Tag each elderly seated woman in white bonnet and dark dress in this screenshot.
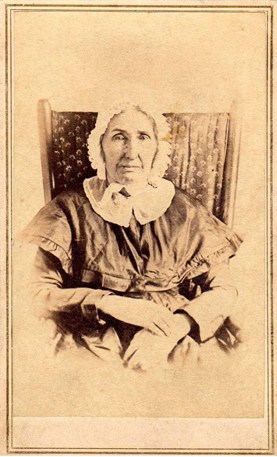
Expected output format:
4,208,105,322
24,105,240,370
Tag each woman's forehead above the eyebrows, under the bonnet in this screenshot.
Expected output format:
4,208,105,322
104,109,156,136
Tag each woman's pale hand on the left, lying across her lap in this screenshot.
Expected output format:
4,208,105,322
97,295,174,336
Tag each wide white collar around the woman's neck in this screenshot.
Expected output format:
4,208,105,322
83,176,175,227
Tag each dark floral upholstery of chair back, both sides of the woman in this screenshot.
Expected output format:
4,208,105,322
51,111,229,217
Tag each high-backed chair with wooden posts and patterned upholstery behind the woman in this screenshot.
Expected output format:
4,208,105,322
38,100,240,227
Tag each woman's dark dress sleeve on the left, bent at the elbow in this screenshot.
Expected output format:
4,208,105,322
31,248,111,323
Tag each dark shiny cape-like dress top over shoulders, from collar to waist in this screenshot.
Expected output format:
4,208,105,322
23,184,240,293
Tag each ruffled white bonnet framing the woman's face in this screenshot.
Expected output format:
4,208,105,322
88,103,171,179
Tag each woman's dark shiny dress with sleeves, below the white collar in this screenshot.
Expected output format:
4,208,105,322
23,183,241,356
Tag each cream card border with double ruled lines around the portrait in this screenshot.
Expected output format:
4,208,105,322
0,0,276,454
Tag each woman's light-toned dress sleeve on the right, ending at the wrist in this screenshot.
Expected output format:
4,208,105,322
177,263,237,342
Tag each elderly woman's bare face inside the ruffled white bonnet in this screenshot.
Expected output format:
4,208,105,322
101,109,158,185
